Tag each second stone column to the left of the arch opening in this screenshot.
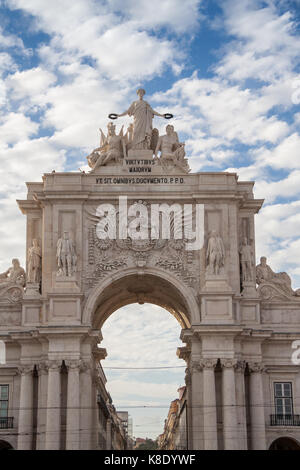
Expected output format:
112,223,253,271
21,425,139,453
65,360,81,450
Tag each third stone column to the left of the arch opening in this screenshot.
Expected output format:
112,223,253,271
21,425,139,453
45,361,61,450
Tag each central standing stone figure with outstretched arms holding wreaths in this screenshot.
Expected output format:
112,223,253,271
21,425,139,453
109,88,173,150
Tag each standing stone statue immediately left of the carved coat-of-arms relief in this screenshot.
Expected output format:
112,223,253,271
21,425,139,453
56,231,77,277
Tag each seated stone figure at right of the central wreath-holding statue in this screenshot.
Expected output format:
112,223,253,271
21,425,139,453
155,124,189,171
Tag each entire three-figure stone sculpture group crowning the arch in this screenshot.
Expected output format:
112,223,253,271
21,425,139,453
87,88,190,173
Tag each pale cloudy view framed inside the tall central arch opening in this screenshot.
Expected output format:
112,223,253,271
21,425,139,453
101,303,186,445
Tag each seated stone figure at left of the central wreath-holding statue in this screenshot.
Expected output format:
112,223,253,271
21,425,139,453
87,122,126,171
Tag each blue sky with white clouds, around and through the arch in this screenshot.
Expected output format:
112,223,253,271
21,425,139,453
0,0,300,435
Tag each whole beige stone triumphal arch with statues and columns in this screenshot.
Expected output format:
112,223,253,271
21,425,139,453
0,90,300,449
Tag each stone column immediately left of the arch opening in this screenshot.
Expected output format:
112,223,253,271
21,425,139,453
80,362,95,450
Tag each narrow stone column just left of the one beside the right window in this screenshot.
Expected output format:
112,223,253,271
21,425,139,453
235,361,248,450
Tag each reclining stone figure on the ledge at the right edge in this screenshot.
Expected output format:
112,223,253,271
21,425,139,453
256,256,300,296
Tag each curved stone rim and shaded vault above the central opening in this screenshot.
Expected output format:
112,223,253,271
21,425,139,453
82,268,200,328
